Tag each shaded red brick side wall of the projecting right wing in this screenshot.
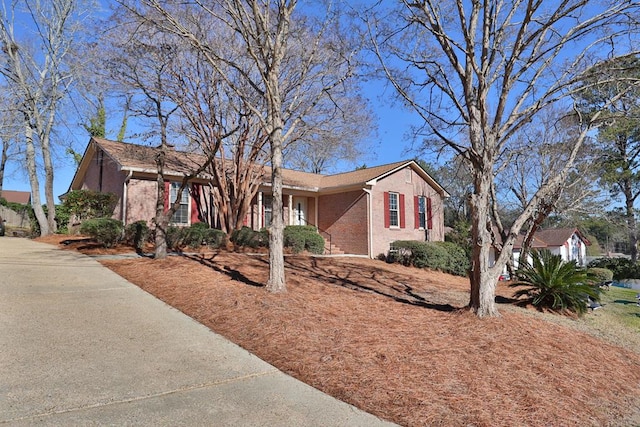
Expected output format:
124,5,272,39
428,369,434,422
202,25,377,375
318,191,368,255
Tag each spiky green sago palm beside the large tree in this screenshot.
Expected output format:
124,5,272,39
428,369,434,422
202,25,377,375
510,250,600,315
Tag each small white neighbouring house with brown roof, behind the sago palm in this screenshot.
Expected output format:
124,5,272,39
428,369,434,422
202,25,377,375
490,228,591,272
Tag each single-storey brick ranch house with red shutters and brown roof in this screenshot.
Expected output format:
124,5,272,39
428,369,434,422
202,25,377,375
69,138,449,258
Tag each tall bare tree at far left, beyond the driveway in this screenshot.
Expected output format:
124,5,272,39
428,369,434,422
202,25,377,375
0,0,84,235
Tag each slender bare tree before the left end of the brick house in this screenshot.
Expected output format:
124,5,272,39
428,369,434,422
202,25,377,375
101,14,215,259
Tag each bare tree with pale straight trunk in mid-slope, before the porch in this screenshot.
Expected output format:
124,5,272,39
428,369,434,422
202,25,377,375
129,0,360,292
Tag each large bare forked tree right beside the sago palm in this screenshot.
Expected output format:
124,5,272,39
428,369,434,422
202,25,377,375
366,0,640,317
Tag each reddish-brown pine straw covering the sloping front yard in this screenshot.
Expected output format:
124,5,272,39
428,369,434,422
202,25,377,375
37,237,640,426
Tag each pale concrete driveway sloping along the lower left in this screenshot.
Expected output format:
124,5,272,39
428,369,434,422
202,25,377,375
0,237,392,426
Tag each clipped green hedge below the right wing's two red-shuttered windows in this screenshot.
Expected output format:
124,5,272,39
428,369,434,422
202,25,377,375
387,240,470,276
